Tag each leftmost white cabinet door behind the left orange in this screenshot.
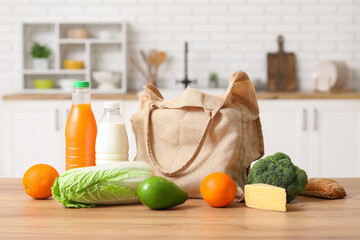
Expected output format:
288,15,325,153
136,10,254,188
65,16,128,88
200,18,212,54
2,101,65,177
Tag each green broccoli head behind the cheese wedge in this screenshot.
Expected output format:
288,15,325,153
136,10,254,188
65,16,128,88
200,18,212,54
248,152,307,202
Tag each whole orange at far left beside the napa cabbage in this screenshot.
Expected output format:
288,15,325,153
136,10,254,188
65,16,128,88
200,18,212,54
23,164,59,198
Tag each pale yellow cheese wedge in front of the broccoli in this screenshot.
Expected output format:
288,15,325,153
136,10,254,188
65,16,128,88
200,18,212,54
245,183,286,212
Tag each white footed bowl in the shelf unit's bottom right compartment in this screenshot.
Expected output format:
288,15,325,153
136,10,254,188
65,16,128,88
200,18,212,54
92,71,121,90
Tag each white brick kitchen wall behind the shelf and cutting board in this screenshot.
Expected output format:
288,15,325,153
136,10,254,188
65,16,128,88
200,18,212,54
0,0,360,175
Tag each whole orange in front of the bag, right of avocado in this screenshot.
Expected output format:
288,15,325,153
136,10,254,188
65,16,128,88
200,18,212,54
200,172,236,207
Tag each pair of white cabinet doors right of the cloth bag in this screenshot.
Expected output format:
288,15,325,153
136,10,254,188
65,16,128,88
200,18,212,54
259,100,360,177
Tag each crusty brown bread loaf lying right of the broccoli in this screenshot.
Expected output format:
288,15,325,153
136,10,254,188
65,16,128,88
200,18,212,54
300,178,346,199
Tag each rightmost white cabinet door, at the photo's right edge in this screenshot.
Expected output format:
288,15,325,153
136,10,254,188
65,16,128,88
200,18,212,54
312,101,360,177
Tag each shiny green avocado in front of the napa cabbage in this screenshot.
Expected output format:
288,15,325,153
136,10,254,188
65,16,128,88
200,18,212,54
137,176,188,210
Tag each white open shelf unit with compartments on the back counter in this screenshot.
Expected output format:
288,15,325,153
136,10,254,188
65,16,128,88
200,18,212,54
22,22,127,93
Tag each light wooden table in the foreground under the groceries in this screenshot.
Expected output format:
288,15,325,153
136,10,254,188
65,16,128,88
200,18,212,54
0,178,360,240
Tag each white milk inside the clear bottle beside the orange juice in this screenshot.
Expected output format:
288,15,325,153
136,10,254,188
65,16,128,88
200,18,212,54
95,122,129,165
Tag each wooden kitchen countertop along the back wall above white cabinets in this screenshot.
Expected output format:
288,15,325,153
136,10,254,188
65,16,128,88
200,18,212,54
2,90,360,100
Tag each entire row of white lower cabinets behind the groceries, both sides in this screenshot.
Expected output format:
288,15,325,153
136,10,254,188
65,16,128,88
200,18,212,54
0,100,360,177
